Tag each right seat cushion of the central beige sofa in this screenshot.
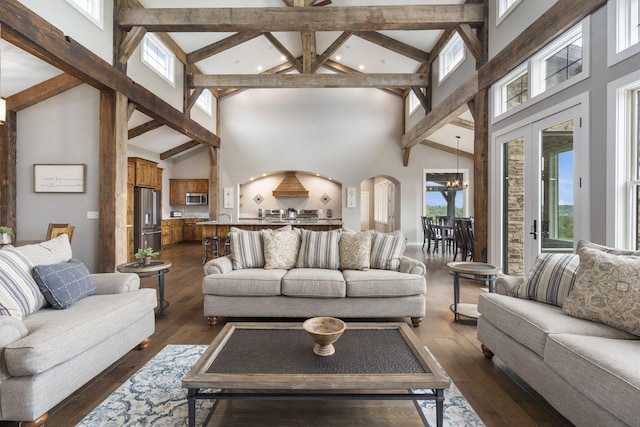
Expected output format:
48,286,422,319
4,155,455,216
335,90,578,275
342,269,427,297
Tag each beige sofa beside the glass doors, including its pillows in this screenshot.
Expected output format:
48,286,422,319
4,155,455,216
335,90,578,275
478,241,640,426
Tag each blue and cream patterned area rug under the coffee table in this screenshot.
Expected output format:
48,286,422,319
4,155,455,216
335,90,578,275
77,345,484,427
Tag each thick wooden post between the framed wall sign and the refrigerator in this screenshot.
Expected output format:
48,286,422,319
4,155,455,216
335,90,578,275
96,90,128,273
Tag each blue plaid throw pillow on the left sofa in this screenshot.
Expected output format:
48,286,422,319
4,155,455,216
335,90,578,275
33,259,97,310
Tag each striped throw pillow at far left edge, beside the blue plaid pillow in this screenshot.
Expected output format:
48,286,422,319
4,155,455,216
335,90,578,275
0,248,45,319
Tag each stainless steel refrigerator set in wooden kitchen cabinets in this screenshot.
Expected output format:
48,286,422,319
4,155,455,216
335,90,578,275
133,187,162,251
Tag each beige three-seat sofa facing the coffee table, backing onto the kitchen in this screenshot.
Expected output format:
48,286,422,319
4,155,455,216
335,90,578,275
202,229,426,326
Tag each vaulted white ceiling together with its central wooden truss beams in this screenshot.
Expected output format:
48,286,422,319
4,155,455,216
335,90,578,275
0,0,485,156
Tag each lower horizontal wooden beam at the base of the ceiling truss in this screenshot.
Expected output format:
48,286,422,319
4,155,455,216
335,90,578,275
188,73,429,88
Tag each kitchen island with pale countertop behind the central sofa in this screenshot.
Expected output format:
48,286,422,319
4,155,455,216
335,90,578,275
196,219,342,254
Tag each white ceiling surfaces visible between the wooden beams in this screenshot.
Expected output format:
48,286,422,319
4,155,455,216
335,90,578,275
0,0,473,157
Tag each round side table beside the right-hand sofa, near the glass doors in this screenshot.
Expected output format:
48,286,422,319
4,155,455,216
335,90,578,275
447,261,500,322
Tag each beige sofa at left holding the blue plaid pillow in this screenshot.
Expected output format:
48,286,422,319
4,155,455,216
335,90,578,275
0,235,156,426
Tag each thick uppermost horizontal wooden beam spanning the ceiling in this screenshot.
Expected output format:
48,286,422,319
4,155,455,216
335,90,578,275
118,4,485,33
